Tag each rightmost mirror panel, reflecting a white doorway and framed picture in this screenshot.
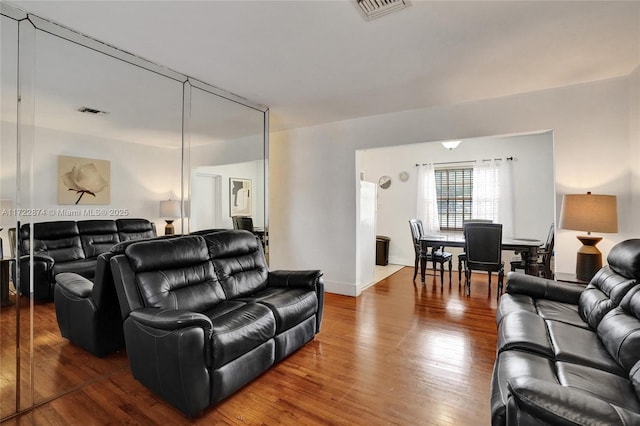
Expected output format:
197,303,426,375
189,83,266,236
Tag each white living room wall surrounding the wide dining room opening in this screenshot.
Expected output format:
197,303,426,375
269,76,640,295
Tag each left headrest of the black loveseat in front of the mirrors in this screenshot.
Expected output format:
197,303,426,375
125,235,209,273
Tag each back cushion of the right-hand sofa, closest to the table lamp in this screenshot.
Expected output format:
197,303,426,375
578,266,636,330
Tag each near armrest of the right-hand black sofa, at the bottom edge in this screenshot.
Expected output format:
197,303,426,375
507,377,640,425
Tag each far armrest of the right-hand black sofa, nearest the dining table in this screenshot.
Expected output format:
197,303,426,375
506,272,585,305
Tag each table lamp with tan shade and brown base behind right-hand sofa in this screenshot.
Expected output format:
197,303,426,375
560,192,618,282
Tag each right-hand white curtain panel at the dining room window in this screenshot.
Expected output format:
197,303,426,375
471,160,514,238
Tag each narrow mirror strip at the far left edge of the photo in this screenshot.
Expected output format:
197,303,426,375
0,10,18,419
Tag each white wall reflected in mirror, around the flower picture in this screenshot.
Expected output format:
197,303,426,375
16,127,181,235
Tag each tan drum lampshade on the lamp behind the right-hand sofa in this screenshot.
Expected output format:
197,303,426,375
560,192,618,233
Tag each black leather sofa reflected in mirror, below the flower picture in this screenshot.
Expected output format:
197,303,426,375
14,218,156,300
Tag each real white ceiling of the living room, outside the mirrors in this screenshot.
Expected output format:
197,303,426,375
9,0,640,131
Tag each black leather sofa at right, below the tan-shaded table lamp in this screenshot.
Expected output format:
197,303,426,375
491,239,640,425
